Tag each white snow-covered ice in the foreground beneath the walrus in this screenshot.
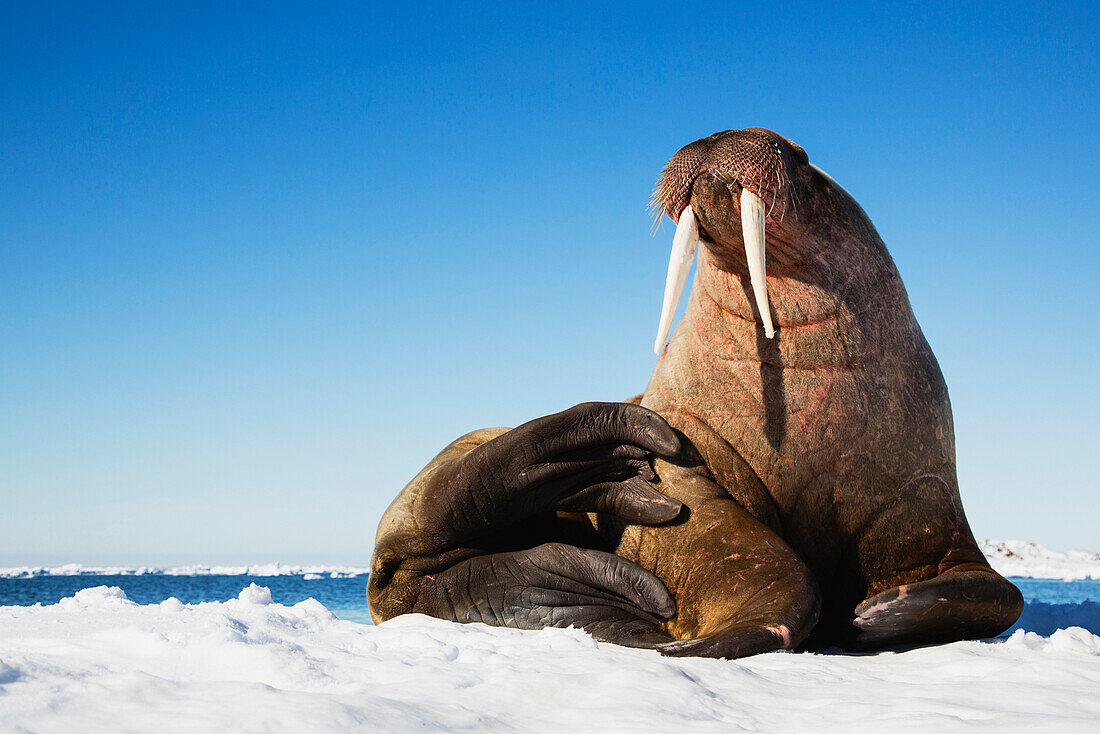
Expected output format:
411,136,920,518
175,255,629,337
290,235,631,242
0,584,1100,732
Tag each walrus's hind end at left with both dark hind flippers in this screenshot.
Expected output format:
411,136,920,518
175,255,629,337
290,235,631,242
367,403,681,644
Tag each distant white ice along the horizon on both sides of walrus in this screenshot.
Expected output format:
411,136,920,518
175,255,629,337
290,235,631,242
0,540,1100,581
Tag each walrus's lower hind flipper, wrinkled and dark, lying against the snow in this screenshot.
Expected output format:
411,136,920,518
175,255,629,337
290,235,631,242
413,543,677,647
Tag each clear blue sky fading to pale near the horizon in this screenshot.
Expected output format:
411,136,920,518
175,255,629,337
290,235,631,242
0,2,1100,566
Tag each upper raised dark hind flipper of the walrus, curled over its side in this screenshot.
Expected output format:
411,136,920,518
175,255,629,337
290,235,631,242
387,403,680,557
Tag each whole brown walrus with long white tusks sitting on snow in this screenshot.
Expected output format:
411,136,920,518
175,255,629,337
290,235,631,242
367,128,1023,658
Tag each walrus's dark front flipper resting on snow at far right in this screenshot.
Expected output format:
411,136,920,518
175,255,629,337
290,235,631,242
847,563,1024,649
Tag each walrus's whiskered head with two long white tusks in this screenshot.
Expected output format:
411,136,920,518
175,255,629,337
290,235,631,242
652,128,833,353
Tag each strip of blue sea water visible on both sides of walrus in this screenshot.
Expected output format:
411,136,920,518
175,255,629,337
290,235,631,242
0,573,1100,635
